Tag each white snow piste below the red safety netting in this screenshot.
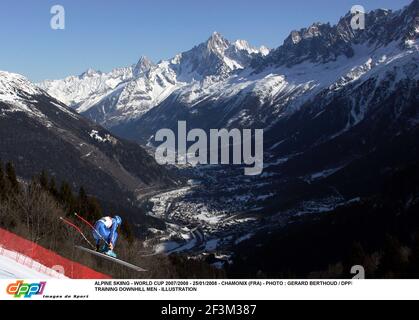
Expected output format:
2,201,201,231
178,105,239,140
0,249,66,279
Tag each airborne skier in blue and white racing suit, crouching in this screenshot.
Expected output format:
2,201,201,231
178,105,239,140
93,216,122,258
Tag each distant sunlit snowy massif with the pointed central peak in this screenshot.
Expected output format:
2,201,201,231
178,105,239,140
38,32,269,127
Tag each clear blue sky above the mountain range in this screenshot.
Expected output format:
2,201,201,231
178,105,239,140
0,0,410,81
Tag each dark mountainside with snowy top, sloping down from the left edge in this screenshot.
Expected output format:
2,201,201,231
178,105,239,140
0,72,176,204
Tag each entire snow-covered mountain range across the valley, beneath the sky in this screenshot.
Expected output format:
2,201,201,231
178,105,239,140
40,1,418,143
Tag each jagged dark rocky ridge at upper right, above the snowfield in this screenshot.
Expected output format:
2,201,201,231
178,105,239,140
252,0,419,71
